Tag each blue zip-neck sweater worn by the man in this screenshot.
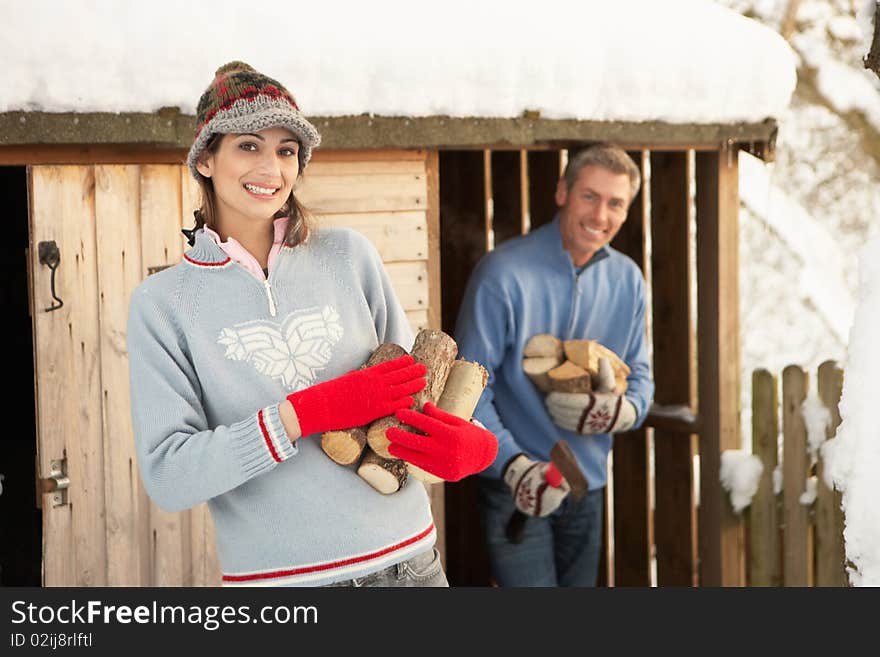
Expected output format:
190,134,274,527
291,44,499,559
455,216,654,489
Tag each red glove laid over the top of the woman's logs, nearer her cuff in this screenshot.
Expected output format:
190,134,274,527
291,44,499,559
287,356,427,436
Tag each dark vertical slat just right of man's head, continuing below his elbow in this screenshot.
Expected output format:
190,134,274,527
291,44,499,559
609,152,654,586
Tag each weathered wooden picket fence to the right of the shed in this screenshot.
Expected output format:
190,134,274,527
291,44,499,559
744,361,848,586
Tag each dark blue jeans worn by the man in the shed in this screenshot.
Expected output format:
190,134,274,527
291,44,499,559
477,477,604,586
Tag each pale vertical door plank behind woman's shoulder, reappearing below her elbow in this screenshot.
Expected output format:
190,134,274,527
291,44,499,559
138,165,189,586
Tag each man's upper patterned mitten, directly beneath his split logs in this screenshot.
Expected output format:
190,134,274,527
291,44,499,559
544,392,637,434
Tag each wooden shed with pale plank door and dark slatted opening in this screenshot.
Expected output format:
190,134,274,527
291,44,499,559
0,110,776,586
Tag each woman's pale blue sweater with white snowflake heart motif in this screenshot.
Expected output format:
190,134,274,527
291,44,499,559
128,229,436,586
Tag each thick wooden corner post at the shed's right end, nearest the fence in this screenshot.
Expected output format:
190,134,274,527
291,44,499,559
696,147,745,586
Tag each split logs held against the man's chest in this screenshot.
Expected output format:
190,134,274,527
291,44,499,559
523,333,630,394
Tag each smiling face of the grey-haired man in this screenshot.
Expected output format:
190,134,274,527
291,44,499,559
556,164,631,267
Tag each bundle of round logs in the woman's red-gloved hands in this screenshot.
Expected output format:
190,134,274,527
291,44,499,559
321,329,488,495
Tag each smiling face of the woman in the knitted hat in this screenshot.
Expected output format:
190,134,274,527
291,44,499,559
196,127,299,233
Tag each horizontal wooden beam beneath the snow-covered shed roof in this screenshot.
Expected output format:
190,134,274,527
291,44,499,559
0,113,776,158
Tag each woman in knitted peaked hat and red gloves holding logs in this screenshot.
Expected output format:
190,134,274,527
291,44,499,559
128,62,497,586
